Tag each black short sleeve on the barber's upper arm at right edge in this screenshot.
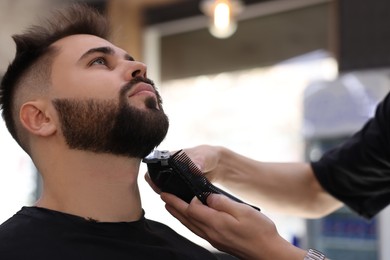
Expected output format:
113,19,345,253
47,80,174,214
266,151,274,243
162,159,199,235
311,94,390,218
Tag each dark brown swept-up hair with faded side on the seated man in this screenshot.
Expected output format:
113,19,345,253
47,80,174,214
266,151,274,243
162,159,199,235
0,4,109,150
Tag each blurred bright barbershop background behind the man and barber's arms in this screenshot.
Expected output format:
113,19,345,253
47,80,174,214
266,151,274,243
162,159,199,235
0,0,390,260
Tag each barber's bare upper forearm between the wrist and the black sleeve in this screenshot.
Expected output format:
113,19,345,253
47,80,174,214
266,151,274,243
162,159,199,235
214,147,342,218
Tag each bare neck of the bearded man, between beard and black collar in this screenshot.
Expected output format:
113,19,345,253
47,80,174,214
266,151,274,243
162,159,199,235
36,151,142,222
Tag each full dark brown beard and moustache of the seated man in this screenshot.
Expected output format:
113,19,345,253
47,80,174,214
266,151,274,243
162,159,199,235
53,78,169,158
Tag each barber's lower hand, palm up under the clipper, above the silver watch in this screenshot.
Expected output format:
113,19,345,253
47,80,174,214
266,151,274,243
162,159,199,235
161,193,305,260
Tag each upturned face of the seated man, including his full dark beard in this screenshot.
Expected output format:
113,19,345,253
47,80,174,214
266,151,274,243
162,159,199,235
50,35,168,158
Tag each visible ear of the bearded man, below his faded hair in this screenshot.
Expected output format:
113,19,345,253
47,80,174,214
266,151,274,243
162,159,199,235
19,101,57,136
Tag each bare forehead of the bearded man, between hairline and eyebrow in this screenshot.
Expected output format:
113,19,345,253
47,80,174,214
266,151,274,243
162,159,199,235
53,34,126,61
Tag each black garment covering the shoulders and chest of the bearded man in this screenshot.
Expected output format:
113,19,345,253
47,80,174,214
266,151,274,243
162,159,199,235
0,207,217,260
